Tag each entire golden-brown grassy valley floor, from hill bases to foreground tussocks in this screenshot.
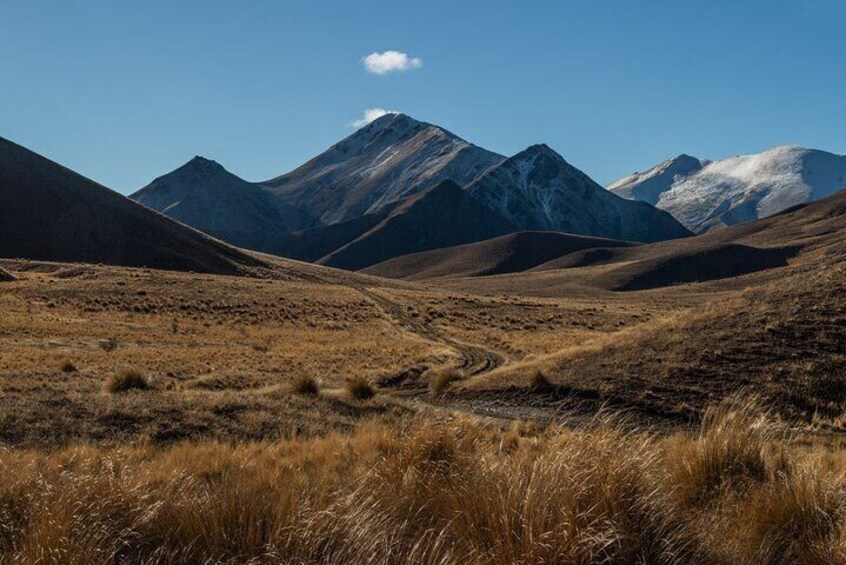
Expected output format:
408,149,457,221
0,261,846,563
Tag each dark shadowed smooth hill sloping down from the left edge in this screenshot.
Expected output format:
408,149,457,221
0,133,265,274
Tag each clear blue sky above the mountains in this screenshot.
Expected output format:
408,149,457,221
0,0,846,193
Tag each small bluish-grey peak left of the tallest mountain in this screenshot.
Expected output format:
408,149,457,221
130,157,314,250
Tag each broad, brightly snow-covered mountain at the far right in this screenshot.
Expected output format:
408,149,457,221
612,146,846,232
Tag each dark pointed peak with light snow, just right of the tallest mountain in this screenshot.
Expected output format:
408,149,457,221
467,145,690,242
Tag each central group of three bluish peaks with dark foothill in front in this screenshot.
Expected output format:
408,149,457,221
132,114,691,269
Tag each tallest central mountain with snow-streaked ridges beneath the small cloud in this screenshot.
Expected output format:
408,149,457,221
261,114,505,224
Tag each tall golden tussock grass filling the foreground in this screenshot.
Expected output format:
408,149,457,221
0,401,846,565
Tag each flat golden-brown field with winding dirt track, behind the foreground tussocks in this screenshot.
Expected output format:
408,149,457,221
0,253,720,447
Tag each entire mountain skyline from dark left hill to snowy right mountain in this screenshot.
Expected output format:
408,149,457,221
0,114,846,280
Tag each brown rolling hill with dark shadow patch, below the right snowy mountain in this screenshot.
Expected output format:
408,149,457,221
428,187,846,296
